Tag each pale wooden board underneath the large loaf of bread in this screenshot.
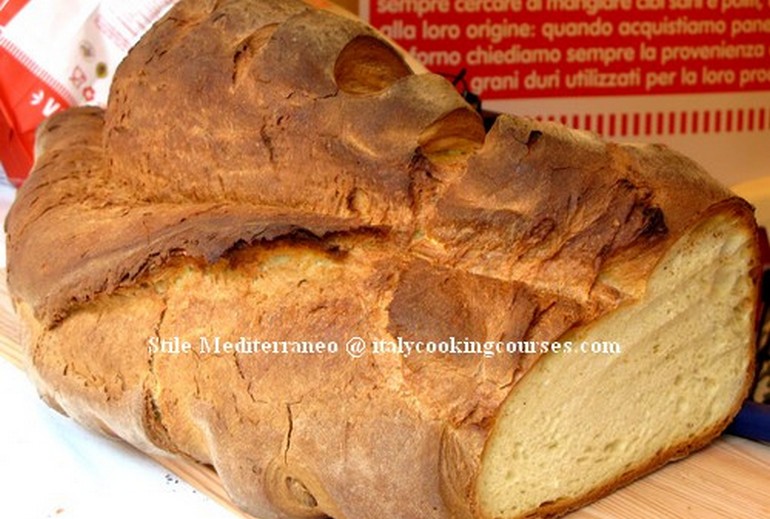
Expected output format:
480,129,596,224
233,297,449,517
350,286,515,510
0,271,770,519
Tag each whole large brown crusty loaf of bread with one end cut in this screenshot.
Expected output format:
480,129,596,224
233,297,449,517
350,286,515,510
6,0,758,519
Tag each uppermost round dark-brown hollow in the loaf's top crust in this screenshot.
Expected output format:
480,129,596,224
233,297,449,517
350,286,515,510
334,36,412,95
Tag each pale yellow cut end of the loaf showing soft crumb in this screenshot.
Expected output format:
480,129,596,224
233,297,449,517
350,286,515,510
476,206,756,518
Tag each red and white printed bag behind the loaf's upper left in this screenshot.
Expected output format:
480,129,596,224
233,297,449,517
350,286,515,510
0,0,176,185
